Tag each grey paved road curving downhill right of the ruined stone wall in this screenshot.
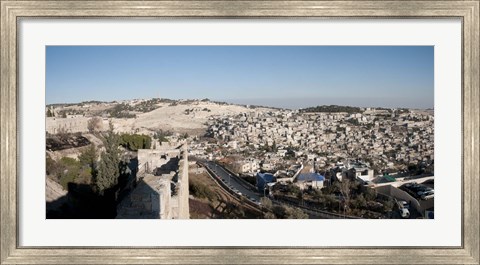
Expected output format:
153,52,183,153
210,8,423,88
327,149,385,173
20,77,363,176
204,161,260,202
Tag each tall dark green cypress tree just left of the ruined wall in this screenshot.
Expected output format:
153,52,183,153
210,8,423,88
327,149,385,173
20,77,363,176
95,121,120,194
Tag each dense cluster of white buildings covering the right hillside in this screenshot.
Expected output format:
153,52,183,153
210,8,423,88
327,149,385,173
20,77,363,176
193,108,434,176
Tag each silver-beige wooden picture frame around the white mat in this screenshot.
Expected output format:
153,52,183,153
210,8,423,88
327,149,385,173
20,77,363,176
0,0,480,264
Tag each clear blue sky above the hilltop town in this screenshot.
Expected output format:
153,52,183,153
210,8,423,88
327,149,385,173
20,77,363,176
46,46,434,109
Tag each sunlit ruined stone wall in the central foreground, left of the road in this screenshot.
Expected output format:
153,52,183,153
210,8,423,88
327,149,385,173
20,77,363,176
117,146,190,219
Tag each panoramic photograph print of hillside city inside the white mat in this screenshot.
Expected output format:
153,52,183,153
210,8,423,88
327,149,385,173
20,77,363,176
45,46,434,219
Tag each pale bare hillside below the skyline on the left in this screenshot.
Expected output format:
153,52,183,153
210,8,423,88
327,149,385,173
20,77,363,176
47,100,274,135
